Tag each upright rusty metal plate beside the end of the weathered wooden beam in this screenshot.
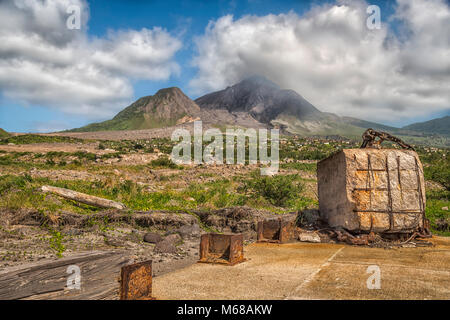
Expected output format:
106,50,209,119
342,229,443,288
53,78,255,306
120,260,154,300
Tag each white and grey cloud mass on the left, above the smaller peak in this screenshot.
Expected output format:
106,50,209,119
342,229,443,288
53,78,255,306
0,0,181,119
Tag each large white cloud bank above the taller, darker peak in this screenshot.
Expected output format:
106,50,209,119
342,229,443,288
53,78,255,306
190,0,450,121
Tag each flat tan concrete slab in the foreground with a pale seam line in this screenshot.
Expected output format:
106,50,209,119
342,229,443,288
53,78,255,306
153,236,450,300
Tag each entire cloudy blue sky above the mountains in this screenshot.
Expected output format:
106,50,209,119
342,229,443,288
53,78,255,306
0,0,450,132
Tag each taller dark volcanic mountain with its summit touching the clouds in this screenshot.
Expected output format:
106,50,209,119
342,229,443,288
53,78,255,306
195,76,396,137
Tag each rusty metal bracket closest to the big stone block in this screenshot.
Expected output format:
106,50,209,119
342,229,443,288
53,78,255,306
257,218,295,243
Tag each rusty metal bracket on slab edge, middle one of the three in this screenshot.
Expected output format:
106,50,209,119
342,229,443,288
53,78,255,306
198,233,245,266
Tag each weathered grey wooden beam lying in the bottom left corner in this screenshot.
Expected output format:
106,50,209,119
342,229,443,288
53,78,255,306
0,251,131,300
